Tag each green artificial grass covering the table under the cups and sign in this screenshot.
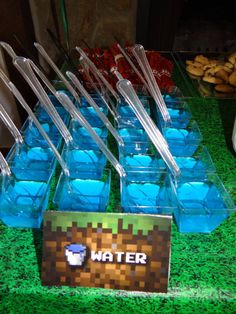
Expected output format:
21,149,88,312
0,76,236,314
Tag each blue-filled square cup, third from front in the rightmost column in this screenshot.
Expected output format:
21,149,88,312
162,121,202,157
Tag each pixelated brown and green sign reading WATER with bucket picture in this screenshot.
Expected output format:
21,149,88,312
42,211,171,292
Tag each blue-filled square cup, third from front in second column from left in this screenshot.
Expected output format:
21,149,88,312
70,120,108,150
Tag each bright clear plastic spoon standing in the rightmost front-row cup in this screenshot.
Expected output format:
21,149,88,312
117,80,180,177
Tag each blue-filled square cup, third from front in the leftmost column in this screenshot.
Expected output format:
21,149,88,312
21,118,62,148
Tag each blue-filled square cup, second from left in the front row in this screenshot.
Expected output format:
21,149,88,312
53,170,111,212
